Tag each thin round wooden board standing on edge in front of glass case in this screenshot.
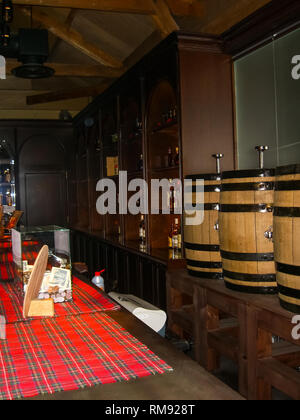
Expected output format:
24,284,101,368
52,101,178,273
23,245,49,318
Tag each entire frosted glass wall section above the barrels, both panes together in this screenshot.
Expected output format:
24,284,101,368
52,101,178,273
235,29,300,169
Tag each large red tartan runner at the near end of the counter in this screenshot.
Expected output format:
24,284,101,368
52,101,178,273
0,313,172,400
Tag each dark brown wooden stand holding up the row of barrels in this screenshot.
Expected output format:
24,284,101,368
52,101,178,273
167,270,300,400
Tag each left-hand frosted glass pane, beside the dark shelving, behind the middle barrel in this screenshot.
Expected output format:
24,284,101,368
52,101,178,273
235,44,277,169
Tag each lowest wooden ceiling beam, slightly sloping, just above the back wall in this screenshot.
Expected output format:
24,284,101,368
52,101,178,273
26,83,110,105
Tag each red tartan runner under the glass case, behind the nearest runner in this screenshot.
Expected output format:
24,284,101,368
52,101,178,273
0,277,120,323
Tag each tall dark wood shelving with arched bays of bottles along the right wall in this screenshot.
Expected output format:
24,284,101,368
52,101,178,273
69,34,234,307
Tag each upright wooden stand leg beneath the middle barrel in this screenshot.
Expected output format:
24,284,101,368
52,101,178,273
247,307,272,400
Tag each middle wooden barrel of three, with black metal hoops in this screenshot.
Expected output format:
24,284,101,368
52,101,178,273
219,170,277,294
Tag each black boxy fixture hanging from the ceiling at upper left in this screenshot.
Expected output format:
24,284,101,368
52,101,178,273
0,29,55,79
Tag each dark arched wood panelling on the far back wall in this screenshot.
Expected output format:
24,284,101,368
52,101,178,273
0,121,73,226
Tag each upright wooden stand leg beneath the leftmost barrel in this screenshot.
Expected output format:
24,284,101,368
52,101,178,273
196,288,220,372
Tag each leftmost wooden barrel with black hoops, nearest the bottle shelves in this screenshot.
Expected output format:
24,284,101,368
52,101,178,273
184,174,222,279
